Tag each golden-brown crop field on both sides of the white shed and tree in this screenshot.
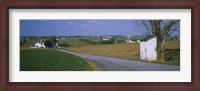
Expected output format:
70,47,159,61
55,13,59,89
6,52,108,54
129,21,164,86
65,40,180,65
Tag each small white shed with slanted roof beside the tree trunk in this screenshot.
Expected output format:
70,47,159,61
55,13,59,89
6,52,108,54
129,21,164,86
140,36,157,61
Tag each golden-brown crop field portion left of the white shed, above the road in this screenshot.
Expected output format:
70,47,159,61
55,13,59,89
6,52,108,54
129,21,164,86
66,43,139,59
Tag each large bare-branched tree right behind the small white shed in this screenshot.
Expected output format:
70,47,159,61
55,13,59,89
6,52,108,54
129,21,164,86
139,20,180,61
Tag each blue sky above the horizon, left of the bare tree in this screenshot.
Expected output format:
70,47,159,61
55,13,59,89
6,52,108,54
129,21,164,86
20,20,180,36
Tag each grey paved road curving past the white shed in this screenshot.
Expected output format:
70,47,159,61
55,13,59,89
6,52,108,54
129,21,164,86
57,49,180,71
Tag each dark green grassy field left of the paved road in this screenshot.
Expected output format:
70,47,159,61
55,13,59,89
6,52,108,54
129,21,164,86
20,49,90,71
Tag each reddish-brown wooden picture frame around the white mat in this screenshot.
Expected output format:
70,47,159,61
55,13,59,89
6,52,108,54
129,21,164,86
0,0,200,91
